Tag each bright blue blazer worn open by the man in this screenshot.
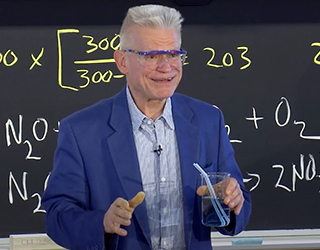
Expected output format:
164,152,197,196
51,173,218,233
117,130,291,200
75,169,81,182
42,88,251,250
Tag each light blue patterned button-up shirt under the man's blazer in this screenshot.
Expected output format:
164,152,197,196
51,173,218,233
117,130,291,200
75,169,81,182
127,87,185,250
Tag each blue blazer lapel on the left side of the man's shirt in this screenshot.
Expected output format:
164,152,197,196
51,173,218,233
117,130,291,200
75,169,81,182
108,88,151,246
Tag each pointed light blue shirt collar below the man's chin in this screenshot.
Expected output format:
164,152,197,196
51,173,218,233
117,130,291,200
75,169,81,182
126,85,175,132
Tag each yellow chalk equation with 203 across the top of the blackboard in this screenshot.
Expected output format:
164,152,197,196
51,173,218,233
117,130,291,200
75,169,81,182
0,28,320,94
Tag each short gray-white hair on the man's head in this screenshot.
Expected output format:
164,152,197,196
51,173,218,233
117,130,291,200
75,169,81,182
120,4,183,49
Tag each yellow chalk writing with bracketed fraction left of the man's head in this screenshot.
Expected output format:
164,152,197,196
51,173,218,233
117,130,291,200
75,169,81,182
0,29,124,91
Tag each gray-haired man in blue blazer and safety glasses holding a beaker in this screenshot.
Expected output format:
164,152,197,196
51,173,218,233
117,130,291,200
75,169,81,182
42,5,251,250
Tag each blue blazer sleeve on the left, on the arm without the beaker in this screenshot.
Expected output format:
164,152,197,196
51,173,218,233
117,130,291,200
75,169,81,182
42,120,105,249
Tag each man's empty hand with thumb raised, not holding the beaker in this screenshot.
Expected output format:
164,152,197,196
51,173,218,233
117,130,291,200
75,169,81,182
103,191,145,236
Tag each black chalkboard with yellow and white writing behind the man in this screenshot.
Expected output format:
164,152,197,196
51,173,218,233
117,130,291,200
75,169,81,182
0,0,320,237
